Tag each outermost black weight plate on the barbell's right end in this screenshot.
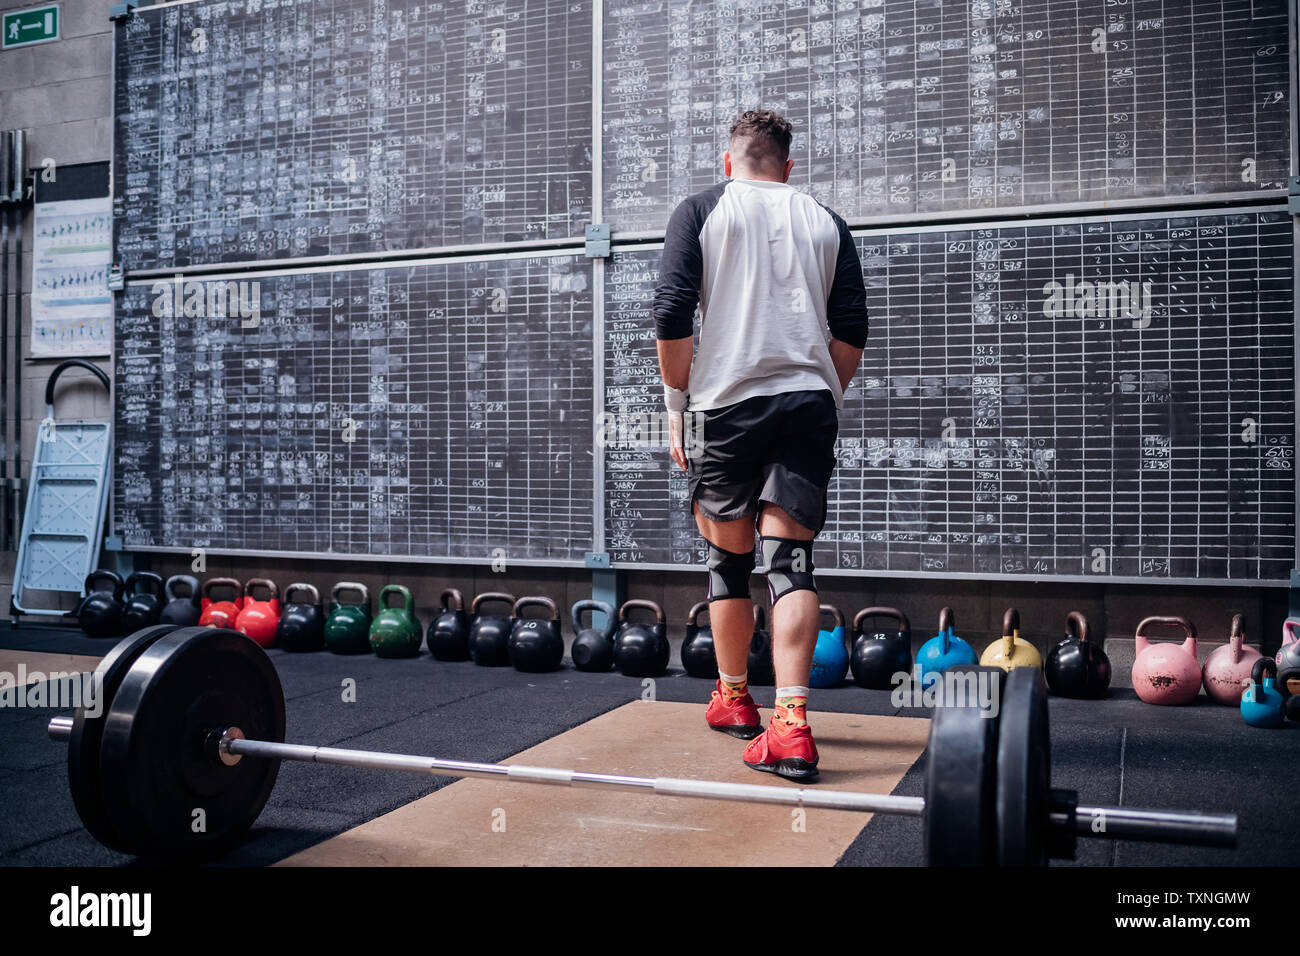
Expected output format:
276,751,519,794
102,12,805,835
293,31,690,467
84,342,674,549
997,667,1052,866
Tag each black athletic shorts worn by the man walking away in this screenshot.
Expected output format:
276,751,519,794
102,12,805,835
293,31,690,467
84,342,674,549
686,390,840,532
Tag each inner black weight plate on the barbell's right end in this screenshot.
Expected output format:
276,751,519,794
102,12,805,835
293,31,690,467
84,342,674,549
923,706,998,866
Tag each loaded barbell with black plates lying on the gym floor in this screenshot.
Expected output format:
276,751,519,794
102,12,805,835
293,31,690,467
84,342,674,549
48,624,1238,866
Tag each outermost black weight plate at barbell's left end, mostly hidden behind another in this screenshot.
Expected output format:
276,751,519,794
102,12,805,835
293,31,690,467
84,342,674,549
68,624,177,849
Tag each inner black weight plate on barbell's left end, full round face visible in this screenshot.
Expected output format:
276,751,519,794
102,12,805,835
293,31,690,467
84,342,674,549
100,628,285,858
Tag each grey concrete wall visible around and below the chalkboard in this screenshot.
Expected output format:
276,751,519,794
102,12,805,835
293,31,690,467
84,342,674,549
0,0,1286,660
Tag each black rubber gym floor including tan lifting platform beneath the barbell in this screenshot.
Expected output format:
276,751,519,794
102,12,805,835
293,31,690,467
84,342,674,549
0,628,1300,866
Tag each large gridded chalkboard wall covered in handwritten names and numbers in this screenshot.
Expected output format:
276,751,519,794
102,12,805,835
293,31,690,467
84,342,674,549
113,0,1296,583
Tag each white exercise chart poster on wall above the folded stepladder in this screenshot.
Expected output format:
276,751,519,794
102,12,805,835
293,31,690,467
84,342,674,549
31,195,113,358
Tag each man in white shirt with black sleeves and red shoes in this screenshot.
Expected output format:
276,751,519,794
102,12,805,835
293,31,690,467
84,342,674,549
654,109,867,782
